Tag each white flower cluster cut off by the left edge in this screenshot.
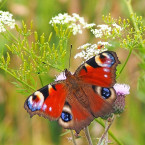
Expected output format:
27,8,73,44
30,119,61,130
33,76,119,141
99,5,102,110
0,11,15,32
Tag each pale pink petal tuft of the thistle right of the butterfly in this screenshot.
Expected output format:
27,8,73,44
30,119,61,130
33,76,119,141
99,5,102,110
113,84,130,95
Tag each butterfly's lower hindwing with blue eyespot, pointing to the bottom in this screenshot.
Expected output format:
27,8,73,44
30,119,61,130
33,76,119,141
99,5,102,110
58,91,94,133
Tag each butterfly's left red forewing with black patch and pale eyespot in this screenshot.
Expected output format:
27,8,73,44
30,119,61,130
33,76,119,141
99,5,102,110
24,81,67,120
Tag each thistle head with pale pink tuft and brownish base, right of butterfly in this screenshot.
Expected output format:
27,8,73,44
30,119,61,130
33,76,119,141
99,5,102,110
113,84,130,114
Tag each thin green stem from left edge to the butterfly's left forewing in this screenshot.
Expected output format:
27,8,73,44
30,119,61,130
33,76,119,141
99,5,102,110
0,67,36,91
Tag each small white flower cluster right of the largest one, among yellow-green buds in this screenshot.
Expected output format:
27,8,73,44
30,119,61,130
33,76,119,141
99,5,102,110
91,23,123,38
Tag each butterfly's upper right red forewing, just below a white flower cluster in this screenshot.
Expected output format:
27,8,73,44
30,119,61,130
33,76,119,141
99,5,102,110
74,51,119,87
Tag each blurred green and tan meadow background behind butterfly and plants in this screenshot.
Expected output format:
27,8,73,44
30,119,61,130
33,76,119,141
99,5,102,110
0,0,145,145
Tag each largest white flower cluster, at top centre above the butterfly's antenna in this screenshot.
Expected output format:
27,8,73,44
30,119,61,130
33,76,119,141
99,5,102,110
49,13,96,35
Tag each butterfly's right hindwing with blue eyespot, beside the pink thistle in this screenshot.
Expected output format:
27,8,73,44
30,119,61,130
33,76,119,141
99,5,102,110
82,85,116,118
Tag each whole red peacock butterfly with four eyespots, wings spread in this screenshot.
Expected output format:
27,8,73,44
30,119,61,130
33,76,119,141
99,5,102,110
24,51,120,133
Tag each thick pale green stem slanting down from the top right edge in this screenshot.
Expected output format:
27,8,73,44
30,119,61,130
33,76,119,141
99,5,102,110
124,0,144,47
